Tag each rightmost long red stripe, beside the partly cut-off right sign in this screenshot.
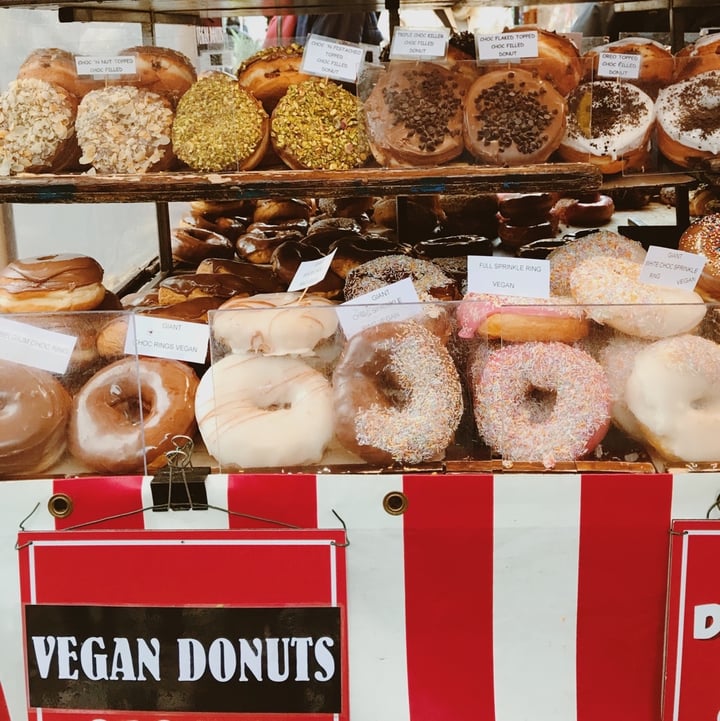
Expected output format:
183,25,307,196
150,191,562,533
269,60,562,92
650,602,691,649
577,474,672,721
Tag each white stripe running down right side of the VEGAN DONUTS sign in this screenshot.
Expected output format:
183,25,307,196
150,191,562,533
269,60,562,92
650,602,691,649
317,475,410,721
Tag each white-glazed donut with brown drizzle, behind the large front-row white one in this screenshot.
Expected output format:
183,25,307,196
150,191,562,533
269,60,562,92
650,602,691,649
213,293,338,356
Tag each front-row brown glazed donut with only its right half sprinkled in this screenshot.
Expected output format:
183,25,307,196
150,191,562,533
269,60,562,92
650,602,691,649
332,322,463,465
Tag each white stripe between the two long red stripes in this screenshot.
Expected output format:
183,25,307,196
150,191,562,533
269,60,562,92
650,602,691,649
493,474,581,721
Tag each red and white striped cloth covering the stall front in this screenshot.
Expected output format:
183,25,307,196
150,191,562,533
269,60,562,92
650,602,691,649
0,474,720,721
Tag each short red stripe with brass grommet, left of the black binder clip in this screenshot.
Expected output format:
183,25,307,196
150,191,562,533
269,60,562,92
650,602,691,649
53,476,145,531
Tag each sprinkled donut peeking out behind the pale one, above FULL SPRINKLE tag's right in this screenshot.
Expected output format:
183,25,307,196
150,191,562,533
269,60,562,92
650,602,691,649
547,230,645,295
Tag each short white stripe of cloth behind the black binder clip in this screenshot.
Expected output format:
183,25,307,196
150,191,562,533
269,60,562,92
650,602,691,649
141,474,230,530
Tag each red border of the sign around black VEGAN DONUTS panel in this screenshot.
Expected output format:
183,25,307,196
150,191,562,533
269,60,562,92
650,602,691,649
18,529,350,721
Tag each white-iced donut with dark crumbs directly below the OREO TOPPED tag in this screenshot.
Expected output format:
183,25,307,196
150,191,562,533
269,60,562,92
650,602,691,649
558,80,655,175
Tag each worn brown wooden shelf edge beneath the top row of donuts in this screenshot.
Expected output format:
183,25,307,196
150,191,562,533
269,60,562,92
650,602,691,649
0,163,602,204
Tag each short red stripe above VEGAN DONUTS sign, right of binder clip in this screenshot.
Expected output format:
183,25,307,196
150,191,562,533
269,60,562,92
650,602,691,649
228,474,317,528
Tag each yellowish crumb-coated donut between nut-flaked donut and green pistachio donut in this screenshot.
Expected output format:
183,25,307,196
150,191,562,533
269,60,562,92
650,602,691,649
172,72,270,172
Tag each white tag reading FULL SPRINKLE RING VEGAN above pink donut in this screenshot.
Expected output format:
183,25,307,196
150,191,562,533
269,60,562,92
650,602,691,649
468,255,550,298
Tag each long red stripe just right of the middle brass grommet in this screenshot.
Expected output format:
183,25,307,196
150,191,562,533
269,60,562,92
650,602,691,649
404,475,495,721
